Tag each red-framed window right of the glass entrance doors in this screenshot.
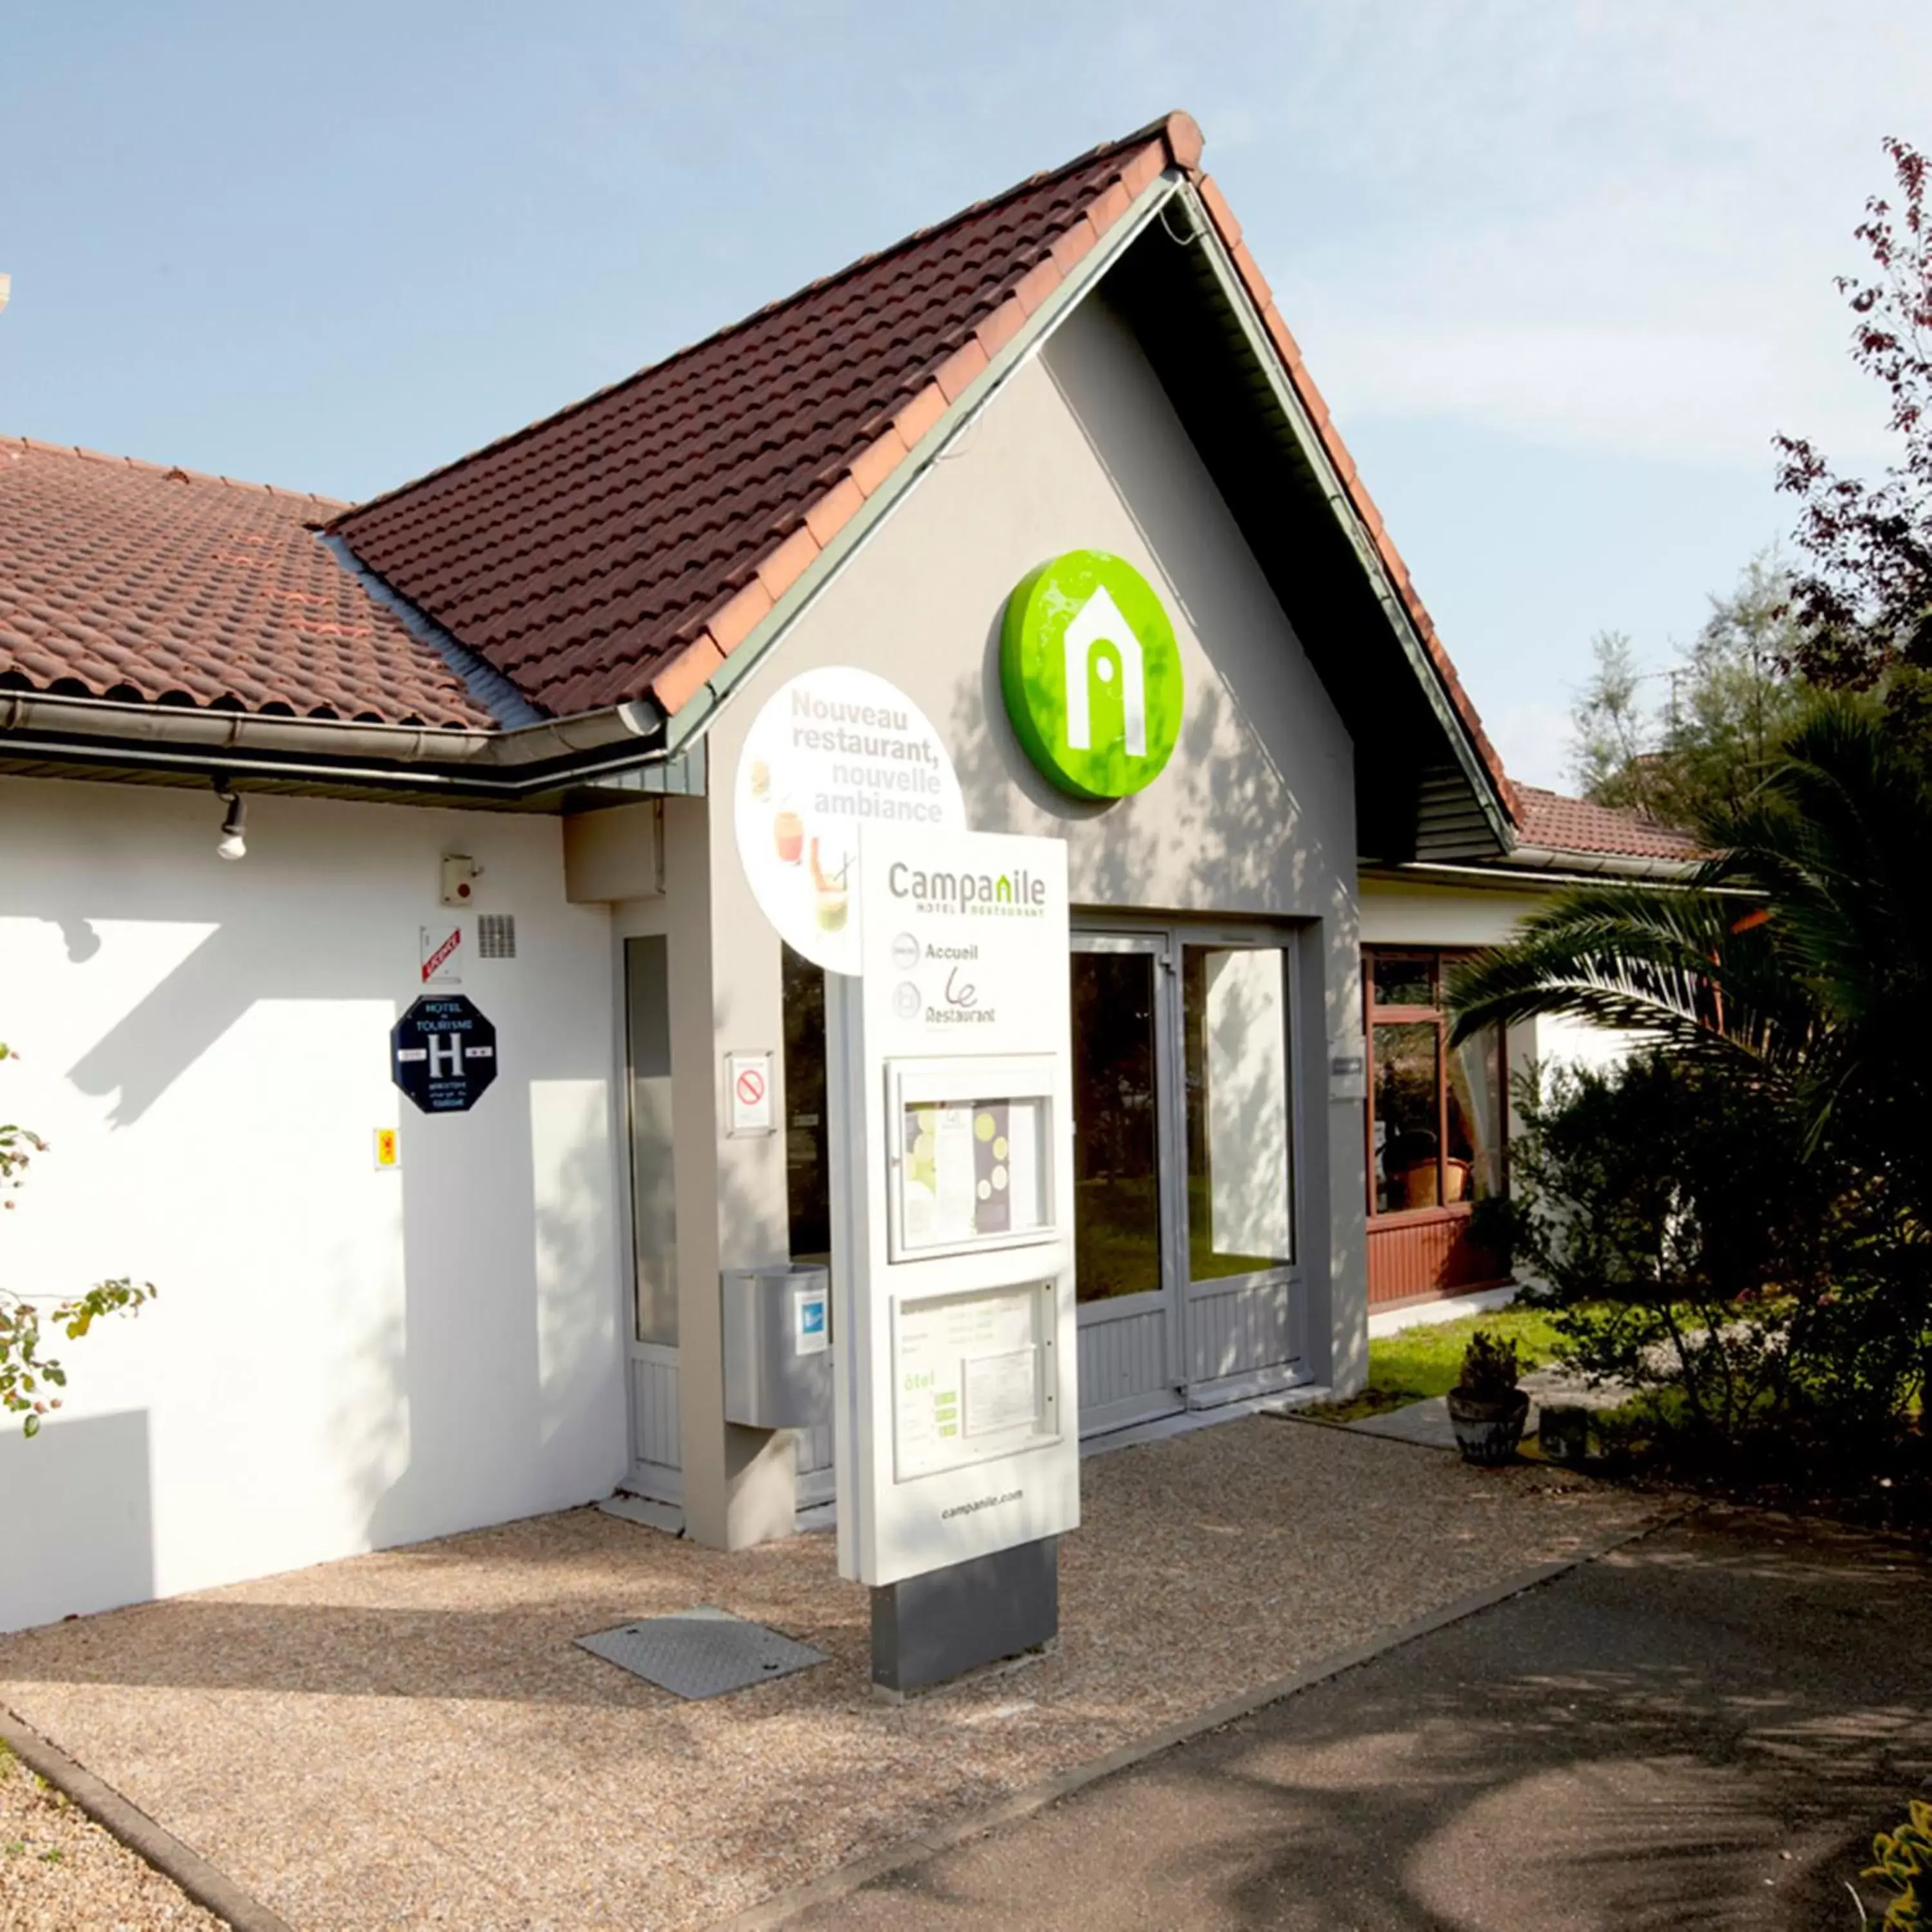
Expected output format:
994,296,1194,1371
1364,949,1509,1215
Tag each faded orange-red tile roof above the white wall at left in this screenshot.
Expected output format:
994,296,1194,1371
0,437,491,726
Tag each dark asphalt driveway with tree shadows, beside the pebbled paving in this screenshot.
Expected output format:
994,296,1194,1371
773,1515,1932,1932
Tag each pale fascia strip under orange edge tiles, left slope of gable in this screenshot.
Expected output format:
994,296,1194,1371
665,168,1186,748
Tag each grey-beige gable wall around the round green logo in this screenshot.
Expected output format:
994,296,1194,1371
665,298,1366,1548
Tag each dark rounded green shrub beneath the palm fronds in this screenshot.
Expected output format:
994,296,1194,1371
1511,1053,1932,1461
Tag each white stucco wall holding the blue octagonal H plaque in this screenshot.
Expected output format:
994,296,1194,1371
0,779,626,1629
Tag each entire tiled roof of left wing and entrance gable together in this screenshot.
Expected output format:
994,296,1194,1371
0,114,1520,817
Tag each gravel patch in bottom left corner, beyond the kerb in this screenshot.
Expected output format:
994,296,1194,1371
0,1745,222,1932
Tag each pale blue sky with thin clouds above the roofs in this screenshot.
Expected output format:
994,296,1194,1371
0,0,1932,784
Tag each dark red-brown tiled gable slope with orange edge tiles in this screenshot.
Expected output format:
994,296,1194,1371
334,116,1200,713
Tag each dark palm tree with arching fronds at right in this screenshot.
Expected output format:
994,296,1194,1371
1449,699,1932,1437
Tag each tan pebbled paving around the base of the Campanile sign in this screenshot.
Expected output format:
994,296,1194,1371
0,1418,1660,1932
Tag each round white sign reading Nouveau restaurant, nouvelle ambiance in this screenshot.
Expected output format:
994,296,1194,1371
734,665,966,974
